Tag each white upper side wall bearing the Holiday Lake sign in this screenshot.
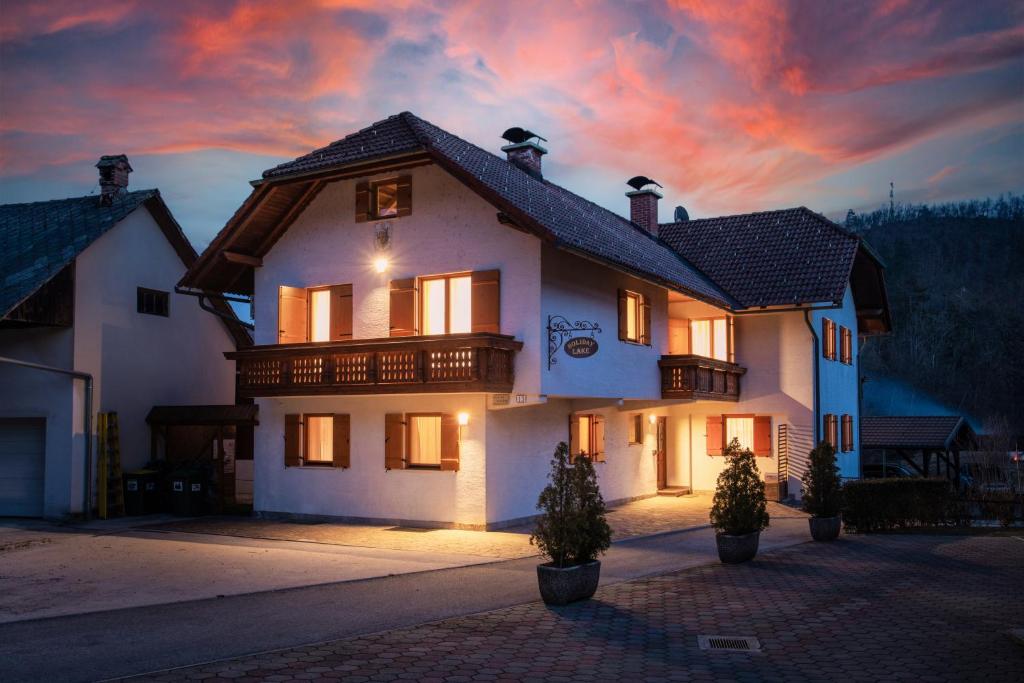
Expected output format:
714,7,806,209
539,247,668,399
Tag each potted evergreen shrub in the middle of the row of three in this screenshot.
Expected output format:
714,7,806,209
711,438,768,564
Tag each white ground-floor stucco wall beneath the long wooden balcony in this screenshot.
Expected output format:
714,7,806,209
254,394,487,526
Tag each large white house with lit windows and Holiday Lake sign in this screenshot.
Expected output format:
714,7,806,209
181,113,889,528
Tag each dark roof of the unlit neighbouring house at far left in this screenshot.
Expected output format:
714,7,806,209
0,189,252,347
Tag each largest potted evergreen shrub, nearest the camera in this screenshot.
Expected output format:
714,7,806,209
529,441,611,605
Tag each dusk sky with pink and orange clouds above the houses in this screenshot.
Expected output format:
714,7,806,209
0,0,1024,249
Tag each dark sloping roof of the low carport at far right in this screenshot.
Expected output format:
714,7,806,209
860,415,976,451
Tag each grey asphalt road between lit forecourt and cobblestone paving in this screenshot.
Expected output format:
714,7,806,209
0,518,809,682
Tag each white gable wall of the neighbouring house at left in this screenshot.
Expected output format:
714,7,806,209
75,208,234,479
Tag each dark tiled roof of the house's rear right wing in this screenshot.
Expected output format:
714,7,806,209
658,207,860,307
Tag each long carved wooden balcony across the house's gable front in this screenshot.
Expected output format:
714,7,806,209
224,334,522,397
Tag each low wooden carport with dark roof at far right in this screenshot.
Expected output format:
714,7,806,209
860,415,978,485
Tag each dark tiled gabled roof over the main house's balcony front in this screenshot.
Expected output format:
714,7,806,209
190,112,735,307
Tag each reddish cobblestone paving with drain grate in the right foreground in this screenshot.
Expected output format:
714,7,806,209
132,536,1024,683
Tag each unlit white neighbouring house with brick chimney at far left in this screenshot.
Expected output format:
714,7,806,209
0,156,246,517
